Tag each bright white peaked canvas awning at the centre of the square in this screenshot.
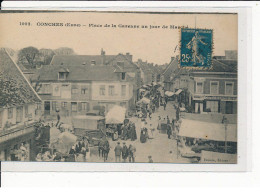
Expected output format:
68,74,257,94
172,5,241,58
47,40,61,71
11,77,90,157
106,105,126,124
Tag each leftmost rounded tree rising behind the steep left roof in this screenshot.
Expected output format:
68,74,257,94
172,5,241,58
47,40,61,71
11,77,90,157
18,47,40,68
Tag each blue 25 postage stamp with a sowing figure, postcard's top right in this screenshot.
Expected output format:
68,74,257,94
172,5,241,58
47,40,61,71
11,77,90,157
180,28,213,67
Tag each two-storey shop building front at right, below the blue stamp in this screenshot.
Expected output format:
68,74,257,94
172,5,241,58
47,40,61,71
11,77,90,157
188,61,237,114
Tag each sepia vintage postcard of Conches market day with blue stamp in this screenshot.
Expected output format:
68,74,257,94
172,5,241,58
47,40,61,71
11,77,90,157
0,11,239,165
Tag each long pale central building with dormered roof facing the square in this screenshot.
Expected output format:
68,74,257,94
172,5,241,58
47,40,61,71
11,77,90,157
33,59,134,116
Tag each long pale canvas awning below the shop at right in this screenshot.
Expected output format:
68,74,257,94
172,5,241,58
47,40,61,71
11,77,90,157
179,119,237,142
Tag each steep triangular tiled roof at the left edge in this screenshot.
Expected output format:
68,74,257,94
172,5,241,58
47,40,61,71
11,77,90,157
0,49,41,107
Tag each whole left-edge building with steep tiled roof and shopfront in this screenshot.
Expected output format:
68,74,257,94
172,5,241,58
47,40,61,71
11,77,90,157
0,49,41,161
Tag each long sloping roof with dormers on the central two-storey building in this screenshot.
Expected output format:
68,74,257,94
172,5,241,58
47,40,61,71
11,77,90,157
32,65,128,82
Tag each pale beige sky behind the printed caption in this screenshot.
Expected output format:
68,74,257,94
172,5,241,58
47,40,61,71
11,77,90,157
0,12,238,65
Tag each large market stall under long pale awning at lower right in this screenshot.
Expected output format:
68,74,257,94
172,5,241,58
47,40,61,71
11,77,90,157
178,119,237,158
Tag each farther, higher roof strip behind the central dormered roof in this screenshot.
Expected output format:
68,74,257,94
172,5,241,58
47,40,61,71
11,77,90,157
50,55,116,65
